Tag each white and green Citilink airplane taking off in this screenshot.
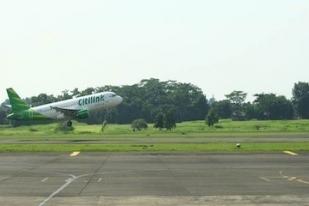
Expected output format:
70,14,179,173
6,88,123,127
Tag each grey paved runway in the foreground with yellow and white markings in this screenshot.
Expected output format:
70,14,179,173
0,153,309,206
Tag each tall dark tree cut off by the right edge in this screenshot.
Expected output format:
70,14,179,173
293,82,309,119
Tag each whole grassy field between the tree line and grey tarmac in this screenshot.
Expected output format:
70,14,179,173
0,120,309,152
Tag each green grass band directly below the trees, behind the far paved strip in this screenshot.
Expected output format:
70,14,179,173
0,120,309,137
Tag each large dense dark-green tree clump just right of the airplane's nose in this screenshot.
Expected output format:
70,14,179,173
113,79,208,123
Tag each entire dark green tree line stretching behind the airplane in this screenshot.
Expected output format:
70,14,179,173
0,78,309,124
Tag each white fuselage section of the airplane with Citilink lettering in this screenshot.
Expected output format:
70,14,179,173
31,92,122,119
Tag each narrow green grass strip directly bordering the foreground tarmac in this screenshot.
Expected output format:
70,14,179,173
0,142,309,152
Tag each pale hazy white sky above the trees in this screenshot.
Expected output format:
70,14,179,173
0,0,309,102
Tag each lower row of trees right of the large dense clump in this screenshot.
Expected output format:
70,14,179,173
209,82,309,120
